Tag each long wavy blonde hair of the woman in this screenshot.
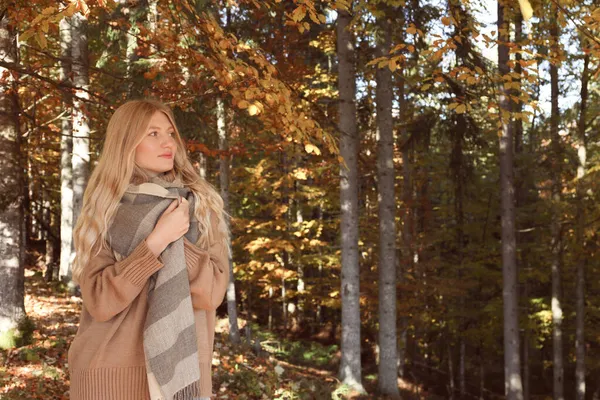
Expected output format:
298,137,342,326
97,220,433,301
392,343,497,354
73,99,229,283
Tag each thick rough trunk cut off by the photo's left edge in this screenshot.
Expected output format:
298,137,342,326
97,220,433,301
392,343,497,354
0,10,25,348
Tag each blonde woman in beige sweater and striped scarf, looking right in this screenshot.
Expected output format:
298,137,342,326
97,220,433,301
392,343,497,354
68,100,229,400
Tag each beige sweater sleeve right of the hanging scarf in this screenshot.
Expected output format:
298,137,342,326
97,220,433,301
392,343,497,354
184,212,229,310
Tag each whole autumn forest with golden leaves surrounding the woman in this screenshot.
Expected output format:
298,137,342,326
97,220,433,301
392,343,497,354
0,0,600,400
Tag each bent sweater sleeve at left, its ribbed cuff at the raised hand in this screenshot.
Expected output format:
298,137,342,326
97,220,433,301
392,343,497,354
81,240,163,322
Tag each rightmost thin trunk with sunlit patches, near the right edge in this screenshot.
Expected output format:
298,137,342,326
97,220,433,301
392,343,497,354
575,53,590,400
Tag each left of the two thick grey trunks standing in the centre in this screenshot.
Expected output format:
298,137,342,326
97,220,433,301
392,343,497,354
337,2,364,392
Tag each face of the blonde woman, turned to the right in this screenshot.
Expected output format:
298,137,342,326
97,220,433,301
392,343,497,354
135,111,177,176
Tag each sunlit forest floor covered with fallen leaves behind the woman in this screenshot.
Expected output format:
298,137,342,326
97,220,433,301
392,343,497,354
0,269,433,400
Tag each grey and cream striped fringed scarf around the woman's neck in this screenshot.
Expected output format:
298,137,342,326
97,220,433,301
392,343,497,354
108,177,200,400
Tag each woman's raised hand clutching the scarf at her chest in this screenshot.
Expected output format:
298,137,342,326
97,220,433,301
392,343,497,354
146,198,190,257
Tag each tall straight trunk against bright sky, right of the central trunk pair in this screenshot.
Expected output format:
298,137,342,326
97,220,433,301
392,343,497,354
498,0,523,400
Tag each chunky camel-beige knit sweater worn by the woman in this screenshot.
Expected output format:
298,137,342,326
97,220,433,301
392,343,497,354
68,221,229,400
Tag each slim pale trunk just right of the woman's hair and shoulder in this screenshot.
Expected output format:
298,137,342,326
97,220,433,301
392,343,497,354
217,98,241,343
